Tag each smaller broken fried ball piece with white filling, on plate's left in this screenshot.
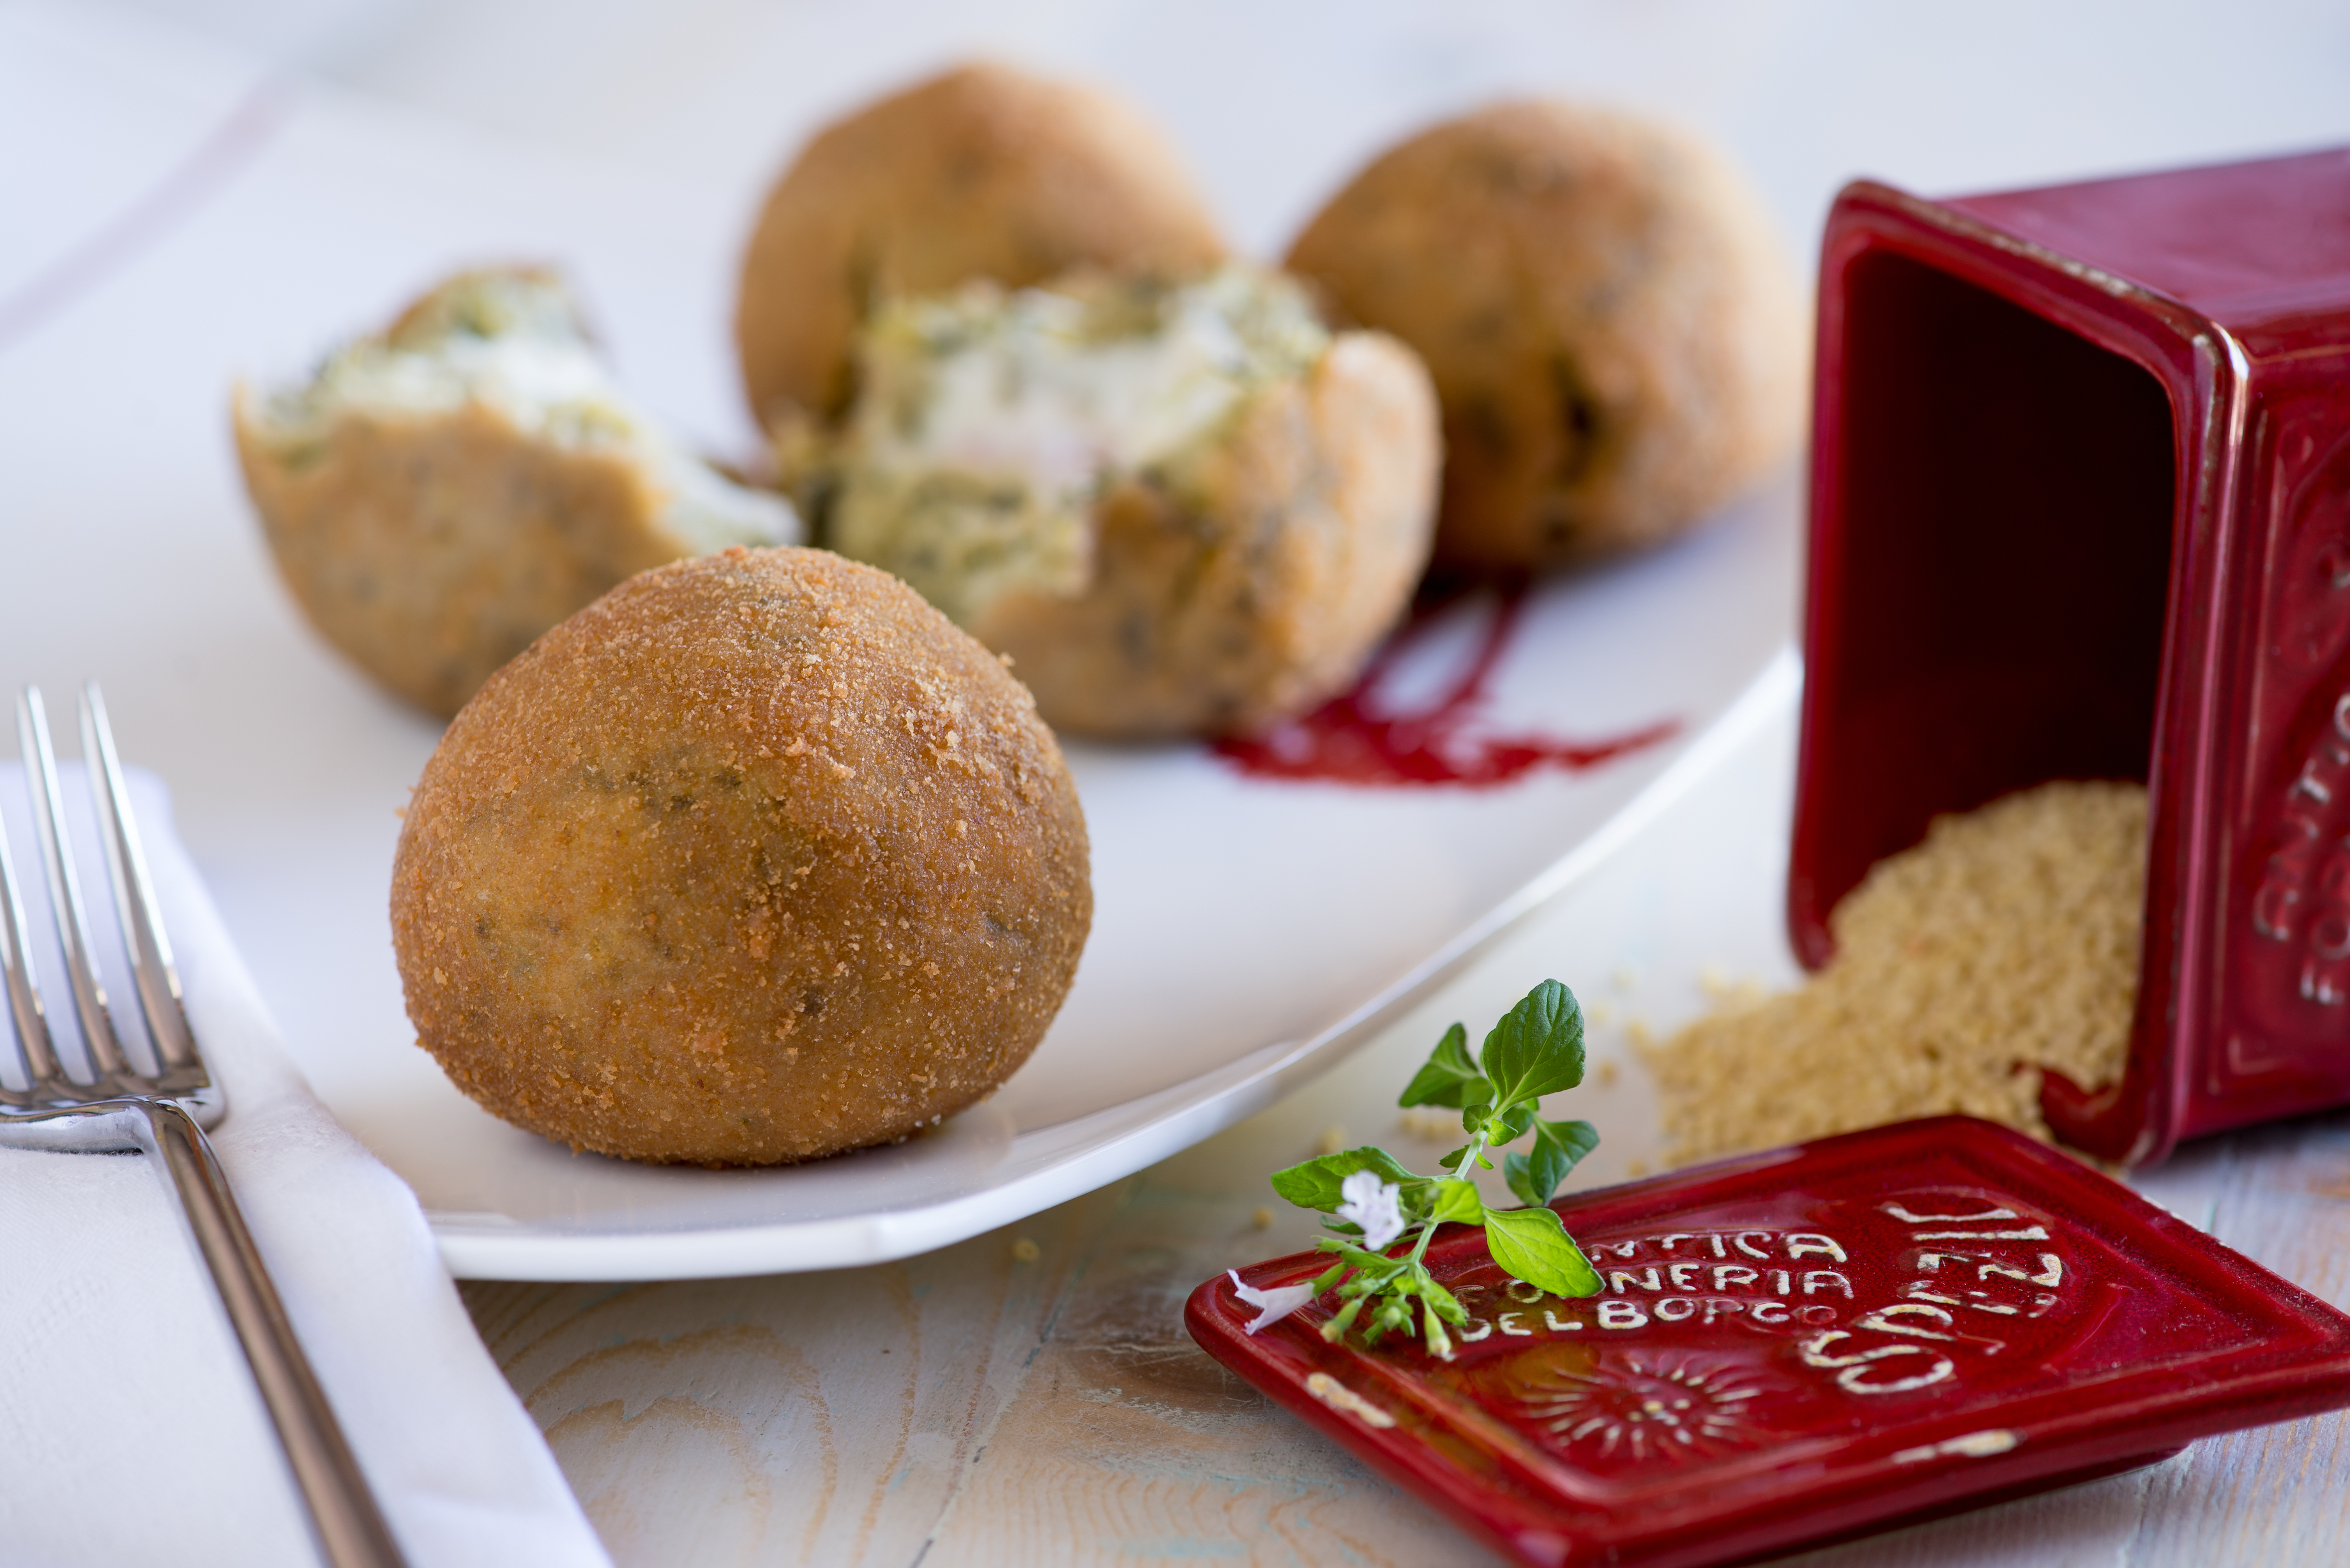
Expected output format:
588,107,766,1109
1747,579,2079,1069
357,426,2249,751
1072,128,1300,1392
232,268,799,717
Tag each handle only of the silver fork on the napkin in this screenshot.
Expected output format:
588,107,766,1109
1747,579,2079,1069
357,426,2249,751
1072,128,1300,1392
139,1100,409,1568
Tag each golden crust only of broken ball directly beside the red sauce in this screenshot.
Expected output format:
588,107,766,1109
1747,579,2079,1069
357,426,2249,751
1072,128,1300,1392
975,331,1438,738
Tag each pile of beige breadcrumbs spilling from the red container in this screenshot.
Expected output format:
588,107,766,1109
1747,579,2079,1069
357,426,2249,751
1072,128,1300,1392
1641,783,2146,1161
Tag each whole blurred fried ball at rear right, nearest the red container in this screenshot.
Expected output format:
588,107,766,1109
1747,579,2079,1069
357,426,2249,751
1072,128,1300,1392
1288,103,1807,569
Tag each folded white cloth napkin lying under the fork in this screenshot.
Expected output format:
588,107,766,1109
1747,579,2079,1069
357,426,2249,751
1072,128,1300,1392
0,764,609,1568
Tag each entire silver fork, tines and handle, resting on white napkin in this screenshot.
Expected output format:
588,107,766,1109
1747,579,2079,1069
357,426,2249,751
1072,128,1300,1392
0,682,407,1568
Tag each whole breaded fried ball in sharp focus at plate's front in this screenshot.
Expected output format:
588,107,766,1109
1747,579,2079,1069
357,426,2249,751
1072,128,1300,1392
393,548,1093,1164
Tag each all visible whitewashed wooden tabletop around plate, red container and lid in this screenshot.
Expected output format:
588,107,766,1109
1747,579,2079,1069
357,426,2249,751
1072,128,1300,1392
463,727,2350,1568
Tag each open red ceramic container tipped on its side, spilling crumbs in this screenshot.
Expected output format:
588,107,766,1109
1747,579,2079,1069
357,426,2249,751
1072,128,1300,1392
1788,151,2350,1161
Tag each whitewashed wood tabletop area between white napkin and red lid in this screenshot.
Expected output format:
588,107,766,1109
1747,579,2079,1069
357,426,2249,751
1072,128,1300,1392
463,1104,1522,1568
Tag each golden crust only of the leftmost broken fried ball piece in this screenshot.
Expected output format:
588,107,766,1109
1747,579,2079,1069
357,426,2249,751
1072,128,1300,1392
235,388,691,717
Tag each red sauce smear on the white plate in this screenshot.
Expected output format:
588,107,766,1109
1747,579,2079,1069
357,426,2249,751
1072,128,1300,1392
1215,580,1680,790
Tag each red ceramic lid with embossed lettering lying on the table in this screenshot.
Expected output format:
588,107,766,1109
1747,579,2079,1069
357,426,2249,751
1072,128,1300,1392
1185,1117,2350,1565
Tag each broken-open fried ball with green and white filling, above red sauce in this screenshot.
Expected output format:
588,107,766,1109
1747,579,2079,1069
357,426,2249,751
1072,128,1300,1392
825,263,1438,738
